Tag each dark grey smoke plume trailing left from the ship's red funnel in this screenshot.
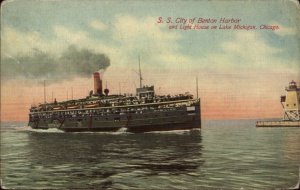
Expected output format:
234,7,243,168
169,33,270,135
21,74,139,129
1,46,110,83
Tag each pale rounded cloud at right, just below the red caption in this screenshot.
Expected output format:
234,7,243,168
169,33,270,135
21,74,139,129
210,31,284,71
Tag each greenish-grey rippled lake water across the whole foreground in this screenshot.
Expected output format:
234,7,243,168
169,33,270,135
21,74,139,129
1,120,300,189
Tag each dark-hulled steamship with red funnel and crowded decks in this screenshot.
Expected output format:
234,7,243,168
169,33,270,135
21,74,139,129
28,64,201,133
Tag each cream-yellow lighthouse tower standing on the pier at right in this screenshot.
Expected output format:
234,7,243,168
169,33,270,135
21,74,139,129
281,81,300,121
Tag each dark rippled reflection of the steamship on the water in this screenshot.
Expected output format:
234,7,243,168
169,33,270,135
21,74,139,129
24,130,204,188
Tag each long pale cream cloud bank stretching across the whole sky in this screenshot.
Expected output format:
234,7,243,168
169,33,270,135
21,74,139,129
1,15,298,88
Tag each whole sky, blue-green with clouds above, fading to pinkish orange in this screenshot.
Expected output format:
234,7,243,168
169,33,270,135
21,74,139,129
1,0,300,121
